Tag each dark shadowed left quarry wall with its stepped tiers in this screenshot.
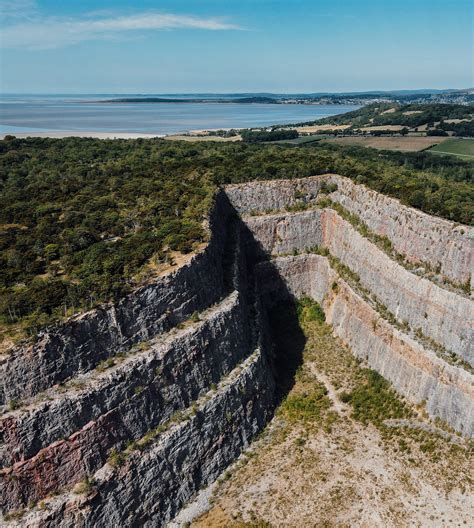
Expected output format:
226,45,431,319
0,194,274,526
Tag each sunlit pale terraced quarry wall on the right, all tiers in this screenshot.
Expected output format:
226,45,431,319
227,175,474,436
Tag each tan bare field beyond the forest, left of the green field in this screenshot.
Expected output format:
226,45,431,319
324,136,446,152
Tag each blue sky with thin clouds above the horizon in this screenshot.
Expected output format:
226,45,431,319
0,0,474,93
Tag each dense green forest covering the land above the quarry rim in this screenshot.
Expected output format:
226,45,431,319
0,137,474,340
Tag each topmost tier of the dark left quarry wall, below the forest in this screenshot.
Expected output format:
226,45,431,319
0,194,235,404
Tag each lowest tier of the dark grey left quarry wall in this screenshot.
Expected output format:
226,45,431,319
19,349,273,528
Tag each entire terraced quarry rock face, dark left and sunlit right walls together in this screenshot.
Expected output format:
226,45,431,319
0,175,474,527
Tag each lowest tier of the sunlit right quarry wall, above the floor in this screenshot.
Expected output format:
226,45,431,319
258,255,474,436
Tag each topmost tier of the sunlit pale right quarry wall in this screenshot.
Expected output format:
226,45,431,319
226,174,474,284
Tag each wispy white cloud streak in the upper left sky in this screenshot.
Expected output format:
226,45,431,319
1,11,242,49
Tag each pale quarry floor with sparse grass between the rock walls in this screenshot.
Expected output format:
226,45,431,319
191,306,474,528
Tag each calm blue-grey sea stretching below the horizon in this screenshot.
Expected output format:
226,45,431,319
0,94,359,135
